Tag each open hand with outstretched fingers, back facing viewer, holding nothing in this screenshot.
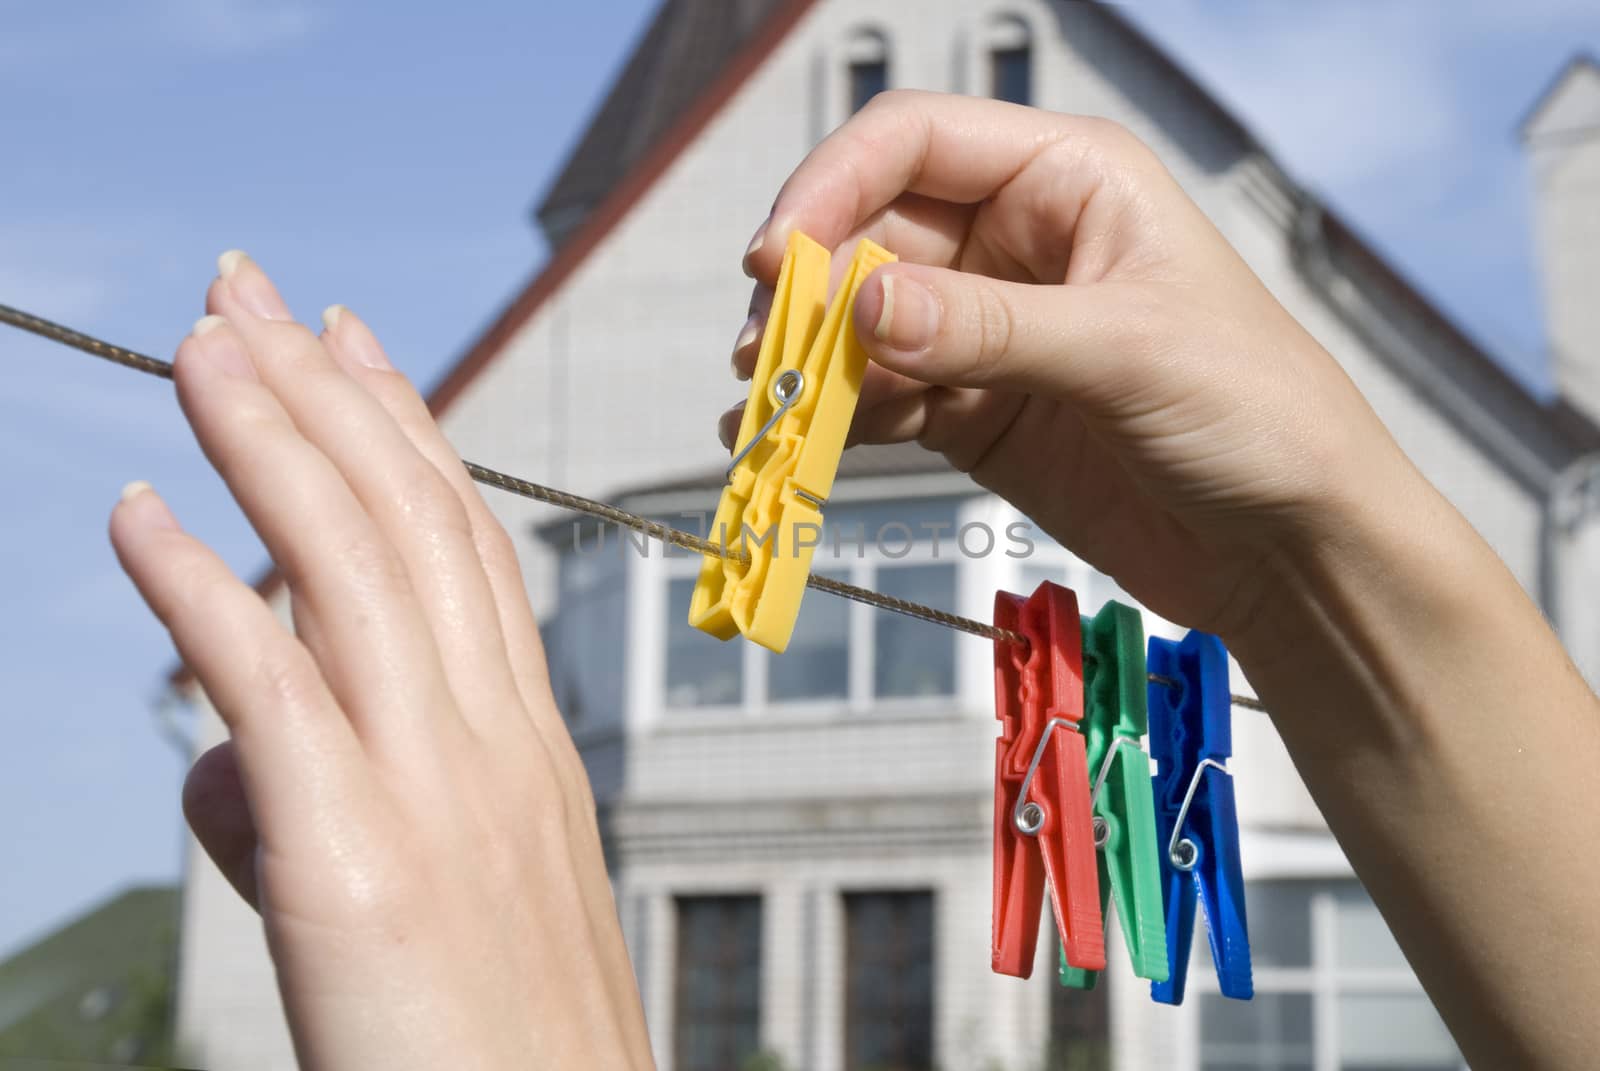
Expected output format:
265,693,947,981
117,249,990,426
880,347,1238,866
110,253,650,1071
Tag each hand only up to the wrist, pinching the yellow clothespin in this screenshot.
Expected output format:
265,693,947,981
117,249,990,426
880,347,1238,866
723,93,1414,656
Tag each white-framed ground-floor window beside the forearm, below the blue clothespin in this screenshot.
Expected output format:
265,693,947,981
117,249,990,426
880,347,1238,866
1189,880,1466,1071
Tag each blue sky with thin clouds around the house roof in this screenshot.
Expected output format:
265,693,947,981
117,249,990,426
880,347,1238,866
0,0,1600,954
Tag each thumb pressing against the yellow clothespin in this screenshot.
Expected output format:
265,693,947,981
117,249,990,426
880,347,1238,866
856,264,1154,400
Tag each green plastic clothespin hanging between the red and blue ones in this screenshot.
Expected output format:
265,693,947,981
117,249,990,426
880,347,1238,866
1061,602,1166,989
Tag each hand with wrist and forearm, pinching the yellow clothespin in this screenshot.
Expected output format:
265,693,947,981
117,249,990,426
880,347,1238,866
723,93,1600,1068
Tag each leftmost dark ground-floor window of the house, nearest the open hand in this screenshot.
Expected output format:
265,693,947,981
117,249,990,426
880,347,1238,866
672,897,762,1071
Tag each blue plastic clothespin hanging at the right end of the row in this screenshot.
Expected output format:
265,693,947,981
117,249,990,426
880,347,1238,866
1149,632,1254,1004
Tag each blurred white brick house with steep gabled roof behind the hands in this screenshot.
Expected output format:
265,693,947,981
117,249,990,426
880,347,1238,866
168,0,1600,1071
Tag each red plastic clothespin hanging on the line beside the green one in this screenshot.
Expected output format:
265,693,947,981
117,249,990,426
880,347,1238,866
992,581,1106,978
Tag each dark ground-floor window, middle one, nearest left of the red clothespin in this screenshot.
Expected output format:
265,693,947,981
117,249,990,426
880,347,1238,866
845,892,933,1071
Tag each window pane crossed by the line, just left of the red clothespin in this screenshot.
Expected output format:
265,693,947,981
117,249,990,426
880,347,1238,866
872,564,955,696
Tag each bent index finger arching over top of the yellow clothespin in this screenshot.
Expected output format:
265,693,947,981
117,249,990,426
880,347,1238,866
746,90,1098,285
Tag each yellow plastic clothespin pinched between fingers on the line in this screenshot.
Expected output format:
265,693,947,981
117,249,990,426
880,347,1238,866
690,234,894,653
